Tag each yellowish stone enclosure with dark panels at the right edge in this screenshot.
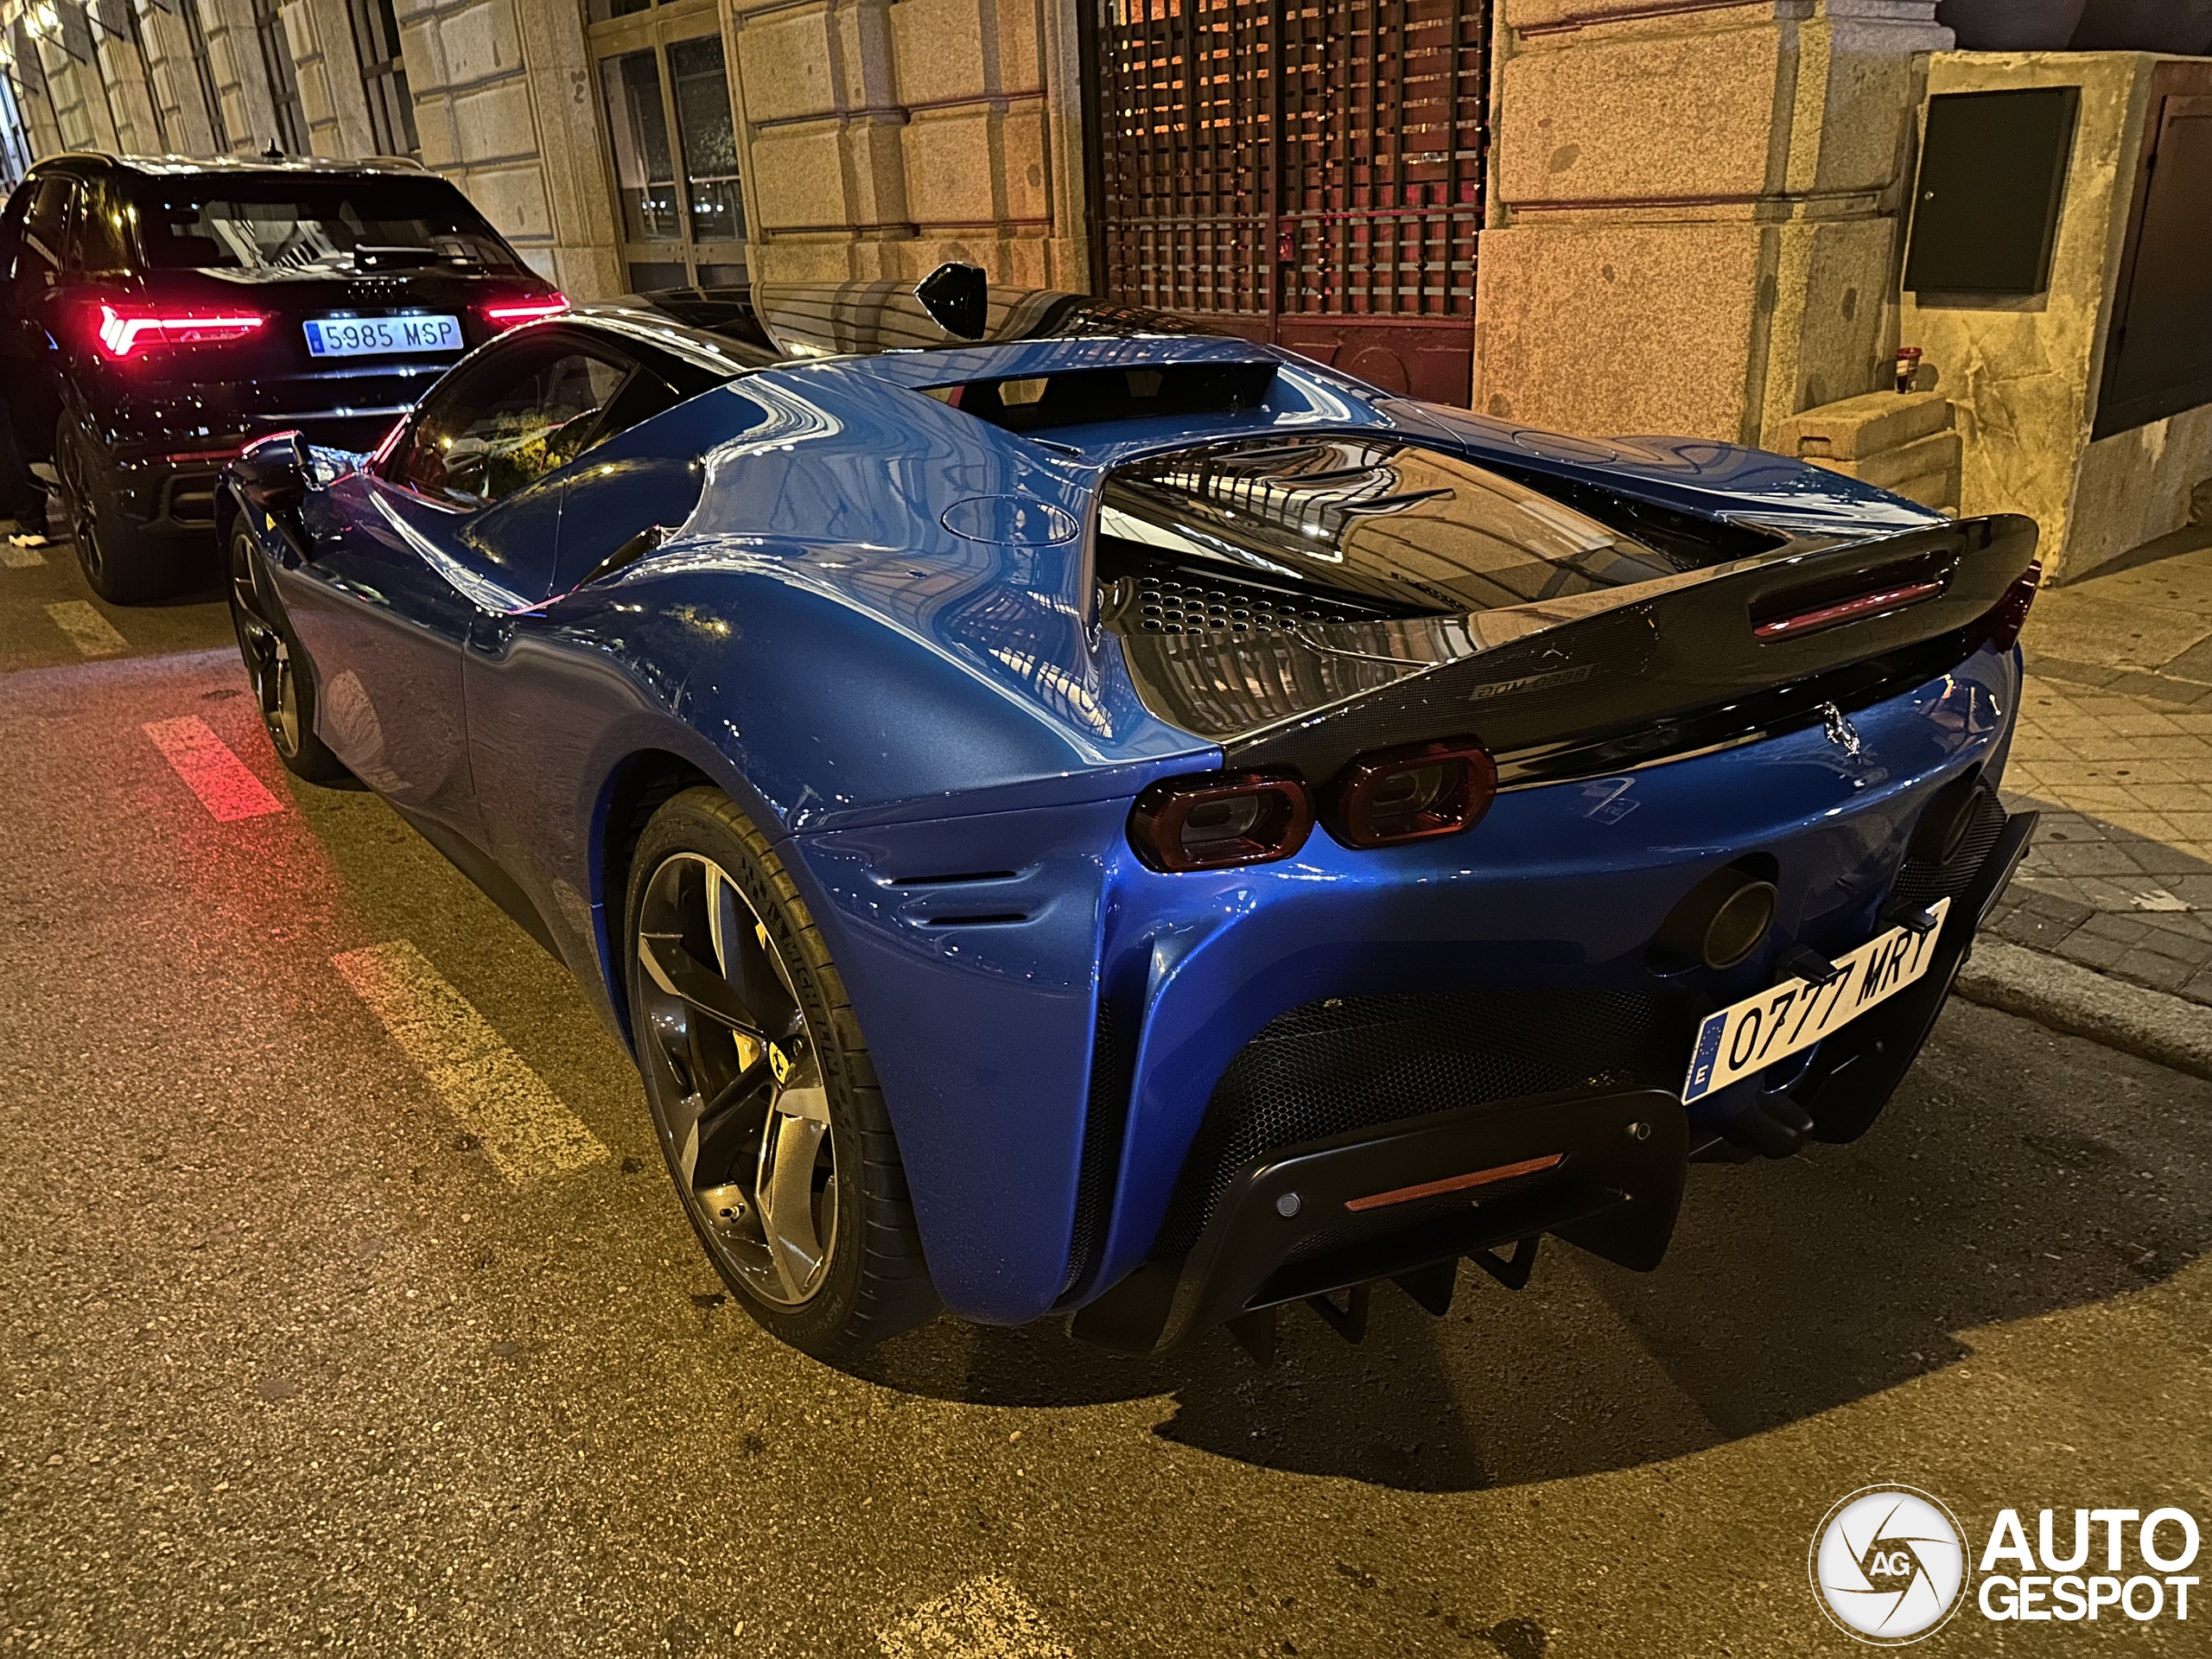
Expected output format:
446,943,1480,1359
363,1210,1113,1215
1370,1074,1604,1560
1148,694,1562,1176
1897,51,2212,580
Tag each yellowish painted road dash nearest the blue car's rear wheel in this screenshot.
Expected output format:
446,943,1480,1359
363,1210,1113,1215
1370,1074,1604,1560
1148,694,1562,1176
329,940,606,1185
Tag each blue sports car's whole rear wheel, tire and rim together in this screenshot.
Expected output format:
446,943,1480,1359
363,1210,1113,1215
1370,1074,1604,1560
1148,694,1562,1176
621,787,938,1360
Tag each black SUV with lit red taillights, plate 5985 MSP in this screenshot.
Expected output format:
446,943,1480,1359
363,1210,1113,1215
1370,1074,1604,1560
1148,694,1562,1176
0,155,564,604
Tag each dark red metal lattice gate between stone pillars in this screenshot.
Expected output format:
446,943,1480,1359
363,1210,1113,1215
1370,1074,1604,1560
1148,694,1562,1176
1086,0,1489,403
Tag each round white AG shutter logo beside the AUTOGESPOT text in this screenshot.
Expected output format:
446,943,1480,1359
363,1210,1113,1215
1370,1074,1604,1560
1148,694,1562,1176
1809,1486,1967,1648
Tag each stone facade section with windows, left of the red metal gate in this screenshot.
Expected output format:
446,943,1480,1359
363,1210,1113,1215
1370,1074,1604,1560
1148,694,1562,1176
0,0,1089,299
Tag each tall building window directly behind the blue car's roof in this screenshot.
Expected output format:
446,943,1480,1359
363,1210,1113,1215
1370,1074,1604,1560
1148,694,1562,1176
591,0,746,292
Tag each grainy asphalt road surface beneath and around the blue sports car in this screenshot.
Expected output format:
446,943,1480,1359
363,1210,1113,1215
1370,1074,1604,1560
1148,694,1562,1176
0,535,2212,1659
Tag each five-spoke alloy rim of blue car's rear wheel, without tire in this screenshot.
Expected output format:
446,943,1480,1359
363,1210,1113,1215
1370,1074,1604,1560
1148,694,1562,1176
635,852,838,1307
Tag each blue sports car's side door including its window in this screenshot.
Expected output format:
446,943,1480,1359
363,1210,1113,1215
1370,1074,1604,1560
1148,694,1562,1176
279,329,632,845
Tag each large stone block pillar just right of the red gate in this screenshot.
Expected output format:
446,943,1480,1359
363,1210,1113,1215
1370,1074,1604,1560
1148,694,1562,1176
1476,0,1951,445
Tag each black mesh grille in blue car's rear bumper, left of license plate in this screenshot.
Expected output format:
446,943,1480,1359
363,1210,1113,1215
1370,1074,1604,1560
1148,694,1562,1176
1153,991,1688,1259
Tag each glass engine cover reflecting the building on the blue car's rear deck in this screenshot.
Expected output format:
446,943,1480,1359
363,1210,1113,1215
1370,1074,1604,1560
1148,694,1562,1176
1099,438,1683,613
